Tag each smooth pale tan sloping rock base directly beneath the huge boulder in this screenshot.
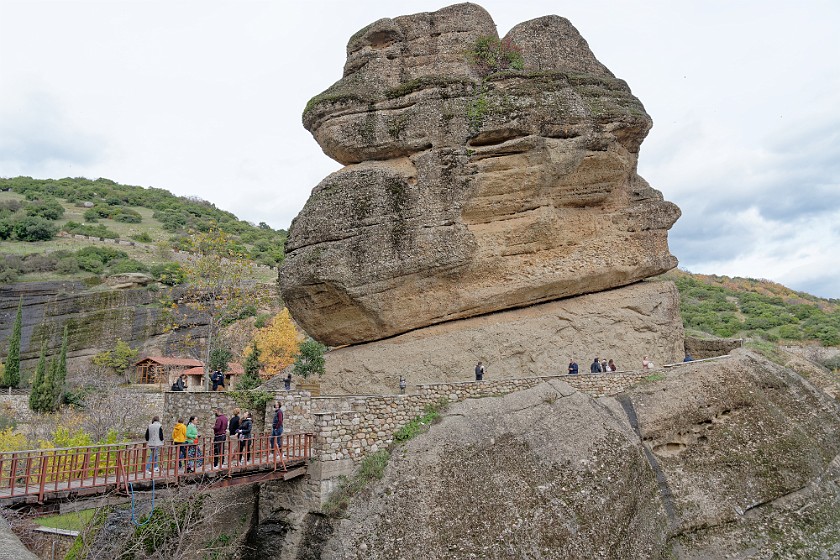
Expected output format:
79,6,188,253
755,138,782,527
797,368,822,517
321,281,684,395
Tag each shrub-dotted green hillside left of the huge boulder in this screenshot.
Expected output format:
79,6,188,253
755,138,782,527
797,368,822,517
0,177,286,282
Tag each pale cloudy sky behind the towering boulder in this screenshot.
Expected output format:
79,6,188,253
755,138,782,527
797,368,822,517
0,0,840,298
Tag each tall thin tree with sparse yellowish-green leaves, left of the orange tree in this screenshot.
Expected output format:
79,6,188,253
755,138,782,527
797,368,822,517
184,227,253,388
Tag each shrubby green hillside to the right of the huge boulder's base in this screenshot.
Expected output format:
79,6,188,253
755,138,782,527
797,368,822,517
663,270,840,346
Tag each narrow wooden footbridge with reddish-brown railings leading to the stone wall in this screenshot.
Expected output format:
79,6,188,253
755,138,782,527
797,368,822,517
0,433,313,506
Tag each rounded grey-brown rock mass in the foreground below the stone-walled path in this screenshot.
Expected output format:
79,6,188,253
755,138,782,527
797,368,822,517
322,350,840,560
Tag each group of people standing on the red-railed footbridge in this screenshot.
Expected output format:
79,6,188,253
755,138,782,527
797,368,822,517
146,401,284,474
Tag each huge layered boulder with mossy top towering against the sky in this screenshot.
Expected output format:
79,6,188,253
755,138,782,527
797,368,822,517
280,4,679,345
